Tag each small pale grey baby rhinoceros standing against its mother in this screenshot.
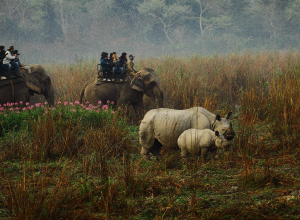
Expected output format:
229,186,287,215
177,129,230,163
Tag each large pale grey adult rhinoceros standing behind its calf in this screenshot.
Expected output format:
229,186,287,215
139,107,235,156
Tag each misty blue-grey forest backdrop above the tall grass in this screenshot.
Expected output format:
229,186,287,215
0,0,300,64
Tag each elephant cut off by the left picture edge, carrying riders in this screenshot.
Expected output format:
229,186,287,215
0,64,54,106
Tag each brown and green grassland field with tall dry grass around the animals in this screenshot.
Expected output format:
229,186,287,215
0,51,300,219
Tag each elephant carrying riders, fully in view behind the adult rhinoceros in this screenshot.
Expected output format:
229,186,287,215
80,68,163,112
